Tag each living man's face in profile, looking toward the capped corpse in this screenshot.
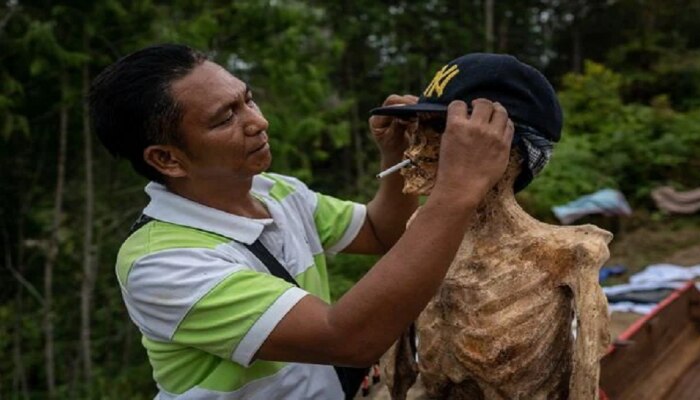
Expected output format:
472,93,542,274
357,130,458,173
171,61,272,179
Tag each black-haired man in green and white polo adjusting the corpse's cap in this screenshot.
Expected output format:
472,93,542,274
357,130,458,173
90,45,513,399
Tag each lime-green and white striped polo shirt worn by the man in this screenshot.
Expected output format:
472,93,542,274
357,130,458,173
116,174,366,400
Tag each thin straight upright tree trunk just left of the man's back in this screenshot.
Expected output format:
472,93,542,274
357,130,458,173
80,47,96,398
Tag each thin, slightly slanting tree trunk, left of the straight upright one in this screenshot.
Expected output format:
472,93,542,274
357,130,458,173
43,72,68,399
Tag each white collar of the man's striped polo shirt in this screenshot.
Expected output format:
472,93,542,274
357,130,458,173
143,176,273,244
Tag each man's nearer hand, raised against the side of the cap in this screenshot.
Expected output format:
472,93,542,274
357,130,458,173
431,99,514,208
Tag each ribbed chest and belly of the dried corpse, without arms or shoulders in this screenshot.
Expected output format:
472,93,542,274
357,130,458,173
418,255,573,400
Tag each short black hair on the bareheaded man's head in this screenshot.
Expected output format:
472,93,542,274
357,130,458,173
89,44,208,183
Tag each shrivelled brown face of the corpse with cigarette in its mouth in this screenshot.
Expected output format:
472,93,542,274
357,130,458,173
401,113,445,195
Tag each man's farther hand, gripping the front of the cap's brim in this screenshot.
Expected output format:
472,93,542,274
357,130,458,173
369,94,418,160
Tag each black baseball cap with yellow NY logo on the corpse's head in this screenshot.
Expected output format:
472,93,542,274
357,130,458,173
370,53,562,142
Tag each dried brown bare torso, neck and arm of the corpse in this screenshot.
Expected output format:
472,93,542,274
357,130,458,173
392,133,612,400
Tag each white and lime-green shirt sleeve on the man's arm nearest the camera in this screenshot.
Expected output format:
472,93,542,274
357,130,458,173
123,249,307,366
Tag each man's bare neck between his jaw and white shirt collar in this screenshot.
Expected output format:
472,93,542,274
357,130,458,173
165,178,270,218
